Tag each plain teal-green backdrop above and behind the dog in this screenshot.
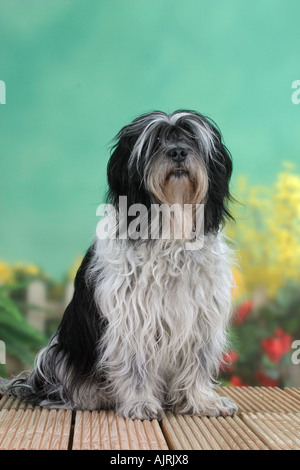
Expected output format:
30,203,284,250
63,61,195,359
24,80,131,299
0,0,300,277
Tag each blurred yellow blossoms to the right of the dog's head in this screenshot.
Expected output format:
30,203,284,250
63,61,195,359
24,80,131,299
227,163,300,296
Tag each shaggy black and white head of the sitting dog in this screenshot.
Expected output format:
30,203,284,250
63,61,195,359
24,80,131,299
107,110,232,233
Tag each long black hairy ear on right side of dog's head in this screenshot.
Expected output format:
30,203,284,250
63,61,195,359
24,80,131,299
204,127,233,233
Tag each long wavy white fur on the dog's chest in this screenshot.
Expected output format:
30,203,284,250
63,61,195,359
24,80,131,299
89,234,231,380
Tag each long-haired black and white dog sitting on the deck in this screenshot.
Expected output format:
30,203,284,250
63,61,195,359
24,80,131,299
2,110,237,419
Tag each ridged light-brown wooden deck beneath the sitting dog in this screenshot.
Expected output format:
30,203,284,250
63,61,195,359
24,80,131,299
0,387,300,451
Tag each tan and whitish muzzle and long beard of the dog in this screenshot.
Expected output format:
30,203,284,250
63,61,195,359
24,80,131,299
145,156,208,240
